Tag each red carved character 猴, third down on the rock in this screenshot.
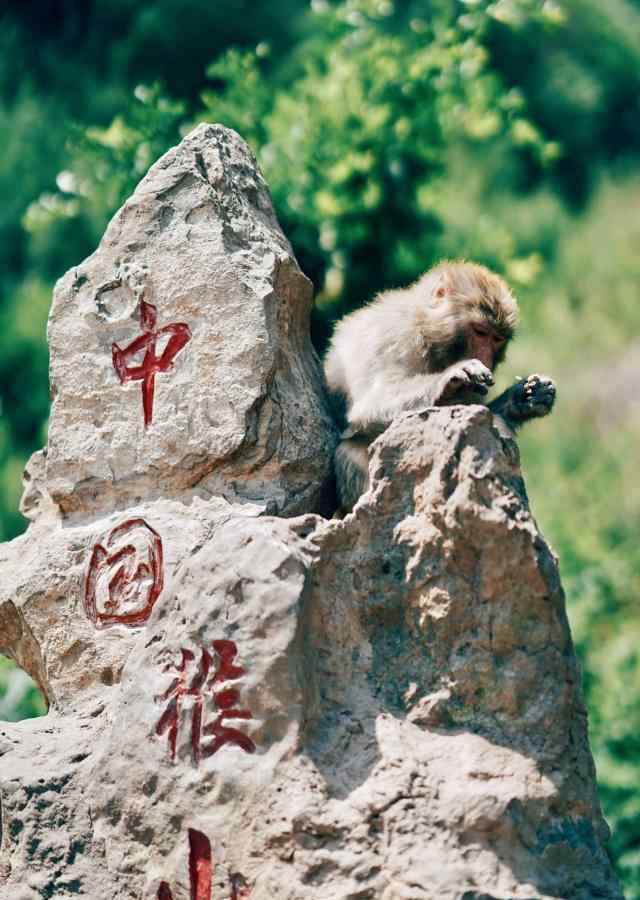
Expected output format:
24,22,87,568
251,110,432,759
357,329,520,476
156,640,256,764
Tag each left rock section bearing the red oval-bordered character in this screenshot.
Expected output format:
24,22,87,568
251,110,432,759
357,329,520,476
0,498,260,712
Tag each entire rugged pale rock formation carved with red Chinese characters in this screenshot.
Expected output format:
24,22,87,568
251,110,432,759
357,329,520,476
0,125,622,900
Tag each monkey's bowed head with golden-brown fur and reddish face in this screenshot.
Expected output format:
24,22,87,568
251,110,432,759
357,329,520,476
422,262,518,371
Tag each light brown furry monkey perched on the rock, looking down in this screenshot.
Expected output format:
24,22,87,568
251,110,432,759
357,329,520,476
324,262,556,511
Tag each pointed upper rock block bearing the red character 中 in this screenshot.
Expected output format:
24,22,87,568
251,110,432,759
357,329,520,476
44,119,334,518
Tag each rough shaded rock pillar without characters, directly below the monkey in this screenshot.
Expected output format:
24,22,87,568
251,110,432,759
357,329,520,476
298,407,621,900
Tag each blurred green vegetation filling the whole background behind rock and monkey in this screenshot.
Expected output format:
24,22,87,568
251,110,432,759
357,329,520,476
0,0,640,900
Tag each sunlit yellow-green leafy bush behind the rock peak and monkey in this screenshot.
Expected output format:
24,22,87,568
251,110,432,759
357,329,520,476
201,0,555,344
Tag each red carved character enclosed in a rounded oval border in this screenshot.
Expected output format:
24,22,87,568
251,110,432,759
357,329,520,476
84,519,164,628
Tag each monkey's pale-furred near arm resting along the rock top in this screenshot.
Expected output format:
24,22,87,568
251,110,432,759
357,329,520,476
348,359,493,432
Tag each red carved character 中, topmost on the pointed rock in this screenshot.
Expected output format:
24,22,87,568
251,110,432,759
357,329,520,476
111,300,191,428
